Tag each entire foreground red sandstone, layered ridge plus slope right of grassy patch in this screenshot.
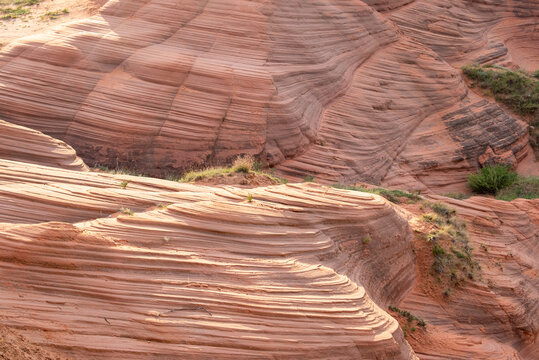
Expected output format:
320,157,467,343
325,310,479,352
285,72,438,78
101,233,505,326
0,156,539,360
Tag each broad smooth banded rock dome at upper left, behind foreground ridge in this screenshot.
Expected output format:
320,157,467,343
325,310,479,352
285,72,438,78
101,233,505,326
0,0,397,172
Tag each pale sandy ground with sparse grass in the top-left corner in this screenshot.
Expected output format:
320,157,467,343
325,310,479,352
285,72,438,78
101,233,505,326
0,0,107,47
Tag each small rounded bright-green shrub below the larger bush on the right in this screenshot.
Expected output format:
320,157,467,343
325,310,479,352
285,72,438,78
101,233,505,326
468,165,517,194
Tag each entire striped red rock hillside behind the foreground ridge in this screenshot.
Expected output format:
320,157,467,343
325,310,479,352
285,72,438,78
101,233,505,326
0,0,539,192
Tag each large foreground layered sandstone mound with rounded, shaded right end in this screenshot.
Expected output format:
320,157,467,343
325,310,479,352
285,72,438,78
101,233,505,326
0,162,415,359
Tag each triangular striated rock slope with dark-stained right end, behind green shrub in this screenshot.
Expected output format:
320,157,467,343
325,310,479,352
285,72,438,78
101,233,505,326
277,39,528,192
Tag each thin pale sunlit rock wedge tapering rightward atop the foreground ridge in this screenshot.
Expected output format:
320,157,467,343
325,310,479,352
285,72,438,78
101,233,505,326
0,160,239,223
